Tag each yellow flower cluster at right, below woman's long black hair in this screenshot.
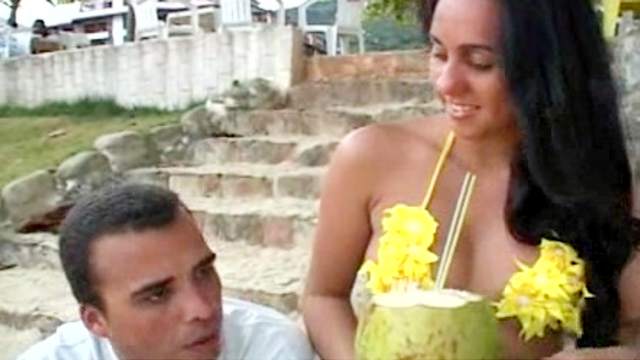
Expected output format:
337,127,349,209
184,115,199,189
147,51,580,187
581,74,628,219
496,239,593,341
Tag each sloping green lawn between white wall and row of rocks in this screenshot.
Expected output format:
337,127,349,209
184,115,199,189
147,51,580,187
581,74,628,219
0,113,180,186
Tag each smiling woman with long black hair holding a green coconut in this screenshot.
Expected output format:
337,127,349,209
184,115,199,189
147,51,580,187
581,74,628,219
303,0,640,359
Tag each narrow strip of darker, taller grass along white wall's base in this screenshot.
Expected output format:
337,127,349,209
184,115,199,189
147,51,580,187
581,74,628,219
0,99,171,119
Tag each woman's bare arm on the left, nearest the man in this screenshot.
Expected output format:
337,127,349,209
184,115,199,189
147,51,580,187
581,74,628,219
302,127,379,359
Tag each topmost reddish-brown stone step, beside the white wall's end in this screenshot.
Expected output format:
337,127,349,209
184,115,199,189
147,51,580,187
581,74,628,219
289,77,435,109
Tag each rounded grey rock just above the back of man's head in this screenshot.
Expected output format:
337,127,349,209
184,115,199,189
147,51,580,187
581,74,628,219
56,151,113,199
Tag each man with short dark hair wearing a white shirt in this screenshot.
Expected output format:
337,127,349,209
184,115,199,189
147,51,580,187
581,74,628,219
19,185,313,360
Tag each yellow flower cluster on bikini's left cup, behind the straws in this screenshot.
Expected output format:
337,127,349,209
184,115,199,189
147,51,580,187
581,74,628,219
361,204,438,294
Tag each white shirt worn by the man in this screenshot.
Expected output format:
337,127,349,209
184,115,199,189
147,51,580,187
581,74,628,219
17,298,314,360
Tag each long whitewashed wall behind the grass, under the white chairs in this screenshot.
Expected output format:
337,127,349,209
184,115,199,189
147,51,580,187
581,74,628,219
0,26,304,109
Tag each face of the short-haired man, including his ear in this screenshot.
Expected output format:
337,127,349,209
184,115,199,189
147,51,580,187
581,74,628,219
82,210,222,359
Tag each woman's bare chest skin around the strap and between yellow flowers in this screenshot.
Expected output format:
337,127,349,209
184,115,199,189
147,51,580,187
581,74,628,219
366,167,538,299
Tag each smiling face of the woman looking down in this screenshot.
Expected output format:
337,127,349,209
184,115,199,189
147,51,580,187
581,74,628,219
430,0,516,138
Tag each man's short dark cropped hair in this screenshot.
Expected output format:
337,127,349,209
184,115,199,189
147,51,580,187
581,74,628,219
60,184,184,309
